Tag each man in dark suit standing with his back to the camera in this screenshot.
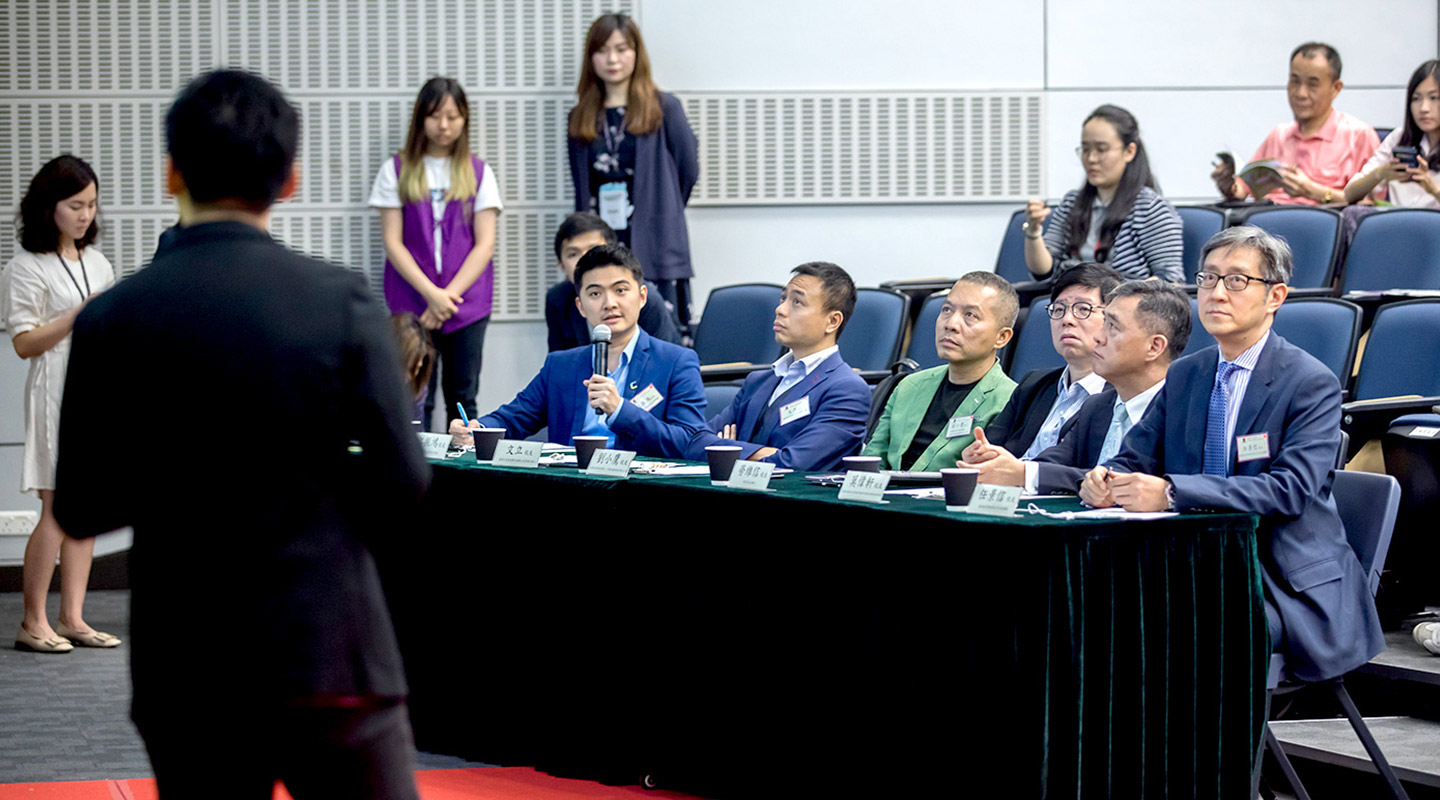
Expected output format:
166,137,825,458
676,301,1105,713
55,71,429,800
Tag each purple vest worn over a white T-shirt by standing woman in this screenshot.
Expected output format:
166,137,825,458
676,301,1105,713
384,155,495,334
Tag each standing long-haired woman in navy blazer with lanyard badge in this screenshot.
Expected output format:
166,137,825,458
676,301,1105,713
569,14,700,327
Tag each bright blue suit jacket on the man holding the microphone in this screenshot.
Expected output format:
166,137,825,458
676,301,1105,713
480,329,706,459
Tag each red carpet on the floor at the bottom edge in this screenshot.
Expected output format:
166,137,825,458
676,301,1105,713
0,767,693,800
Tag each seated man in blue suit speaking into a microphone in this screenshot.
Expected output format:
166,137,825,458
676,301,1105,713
451,245,706,458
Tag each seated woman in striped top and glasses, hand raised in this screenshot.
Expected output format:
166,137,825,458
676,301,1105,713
1022,105,1185,283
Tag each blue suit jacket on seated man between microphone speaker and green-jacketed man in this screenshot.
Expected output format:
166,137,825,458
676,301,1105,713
685,353,870,471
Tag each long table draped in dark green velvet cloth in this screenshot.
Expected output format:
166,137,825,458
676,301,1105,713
382,453,1269,797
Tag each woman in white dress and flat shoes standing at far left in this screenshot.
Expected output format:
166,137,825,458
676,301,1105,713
0,155,120,653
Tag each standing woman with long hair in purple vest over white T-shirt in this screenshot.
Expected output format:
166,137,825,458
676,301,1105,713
370,78,504,427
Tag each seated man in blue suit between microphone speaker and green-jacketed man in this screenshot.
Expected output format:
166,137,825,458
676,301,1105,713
685,262,870,471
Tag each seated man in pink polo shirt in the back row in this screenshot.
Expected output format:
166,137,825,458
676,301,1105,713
1210,42,1380,206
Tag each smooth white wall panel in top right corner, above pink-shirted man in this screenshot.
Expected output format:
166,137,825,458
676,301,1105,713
1047,0,1436,89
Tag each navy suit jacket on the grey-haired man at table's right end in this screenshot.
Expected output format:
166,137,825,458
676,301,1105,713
1107,331,1385,681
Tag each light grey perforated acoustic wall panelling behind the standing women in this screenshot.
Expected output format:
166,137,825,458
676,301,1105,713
0,0,1044,319
